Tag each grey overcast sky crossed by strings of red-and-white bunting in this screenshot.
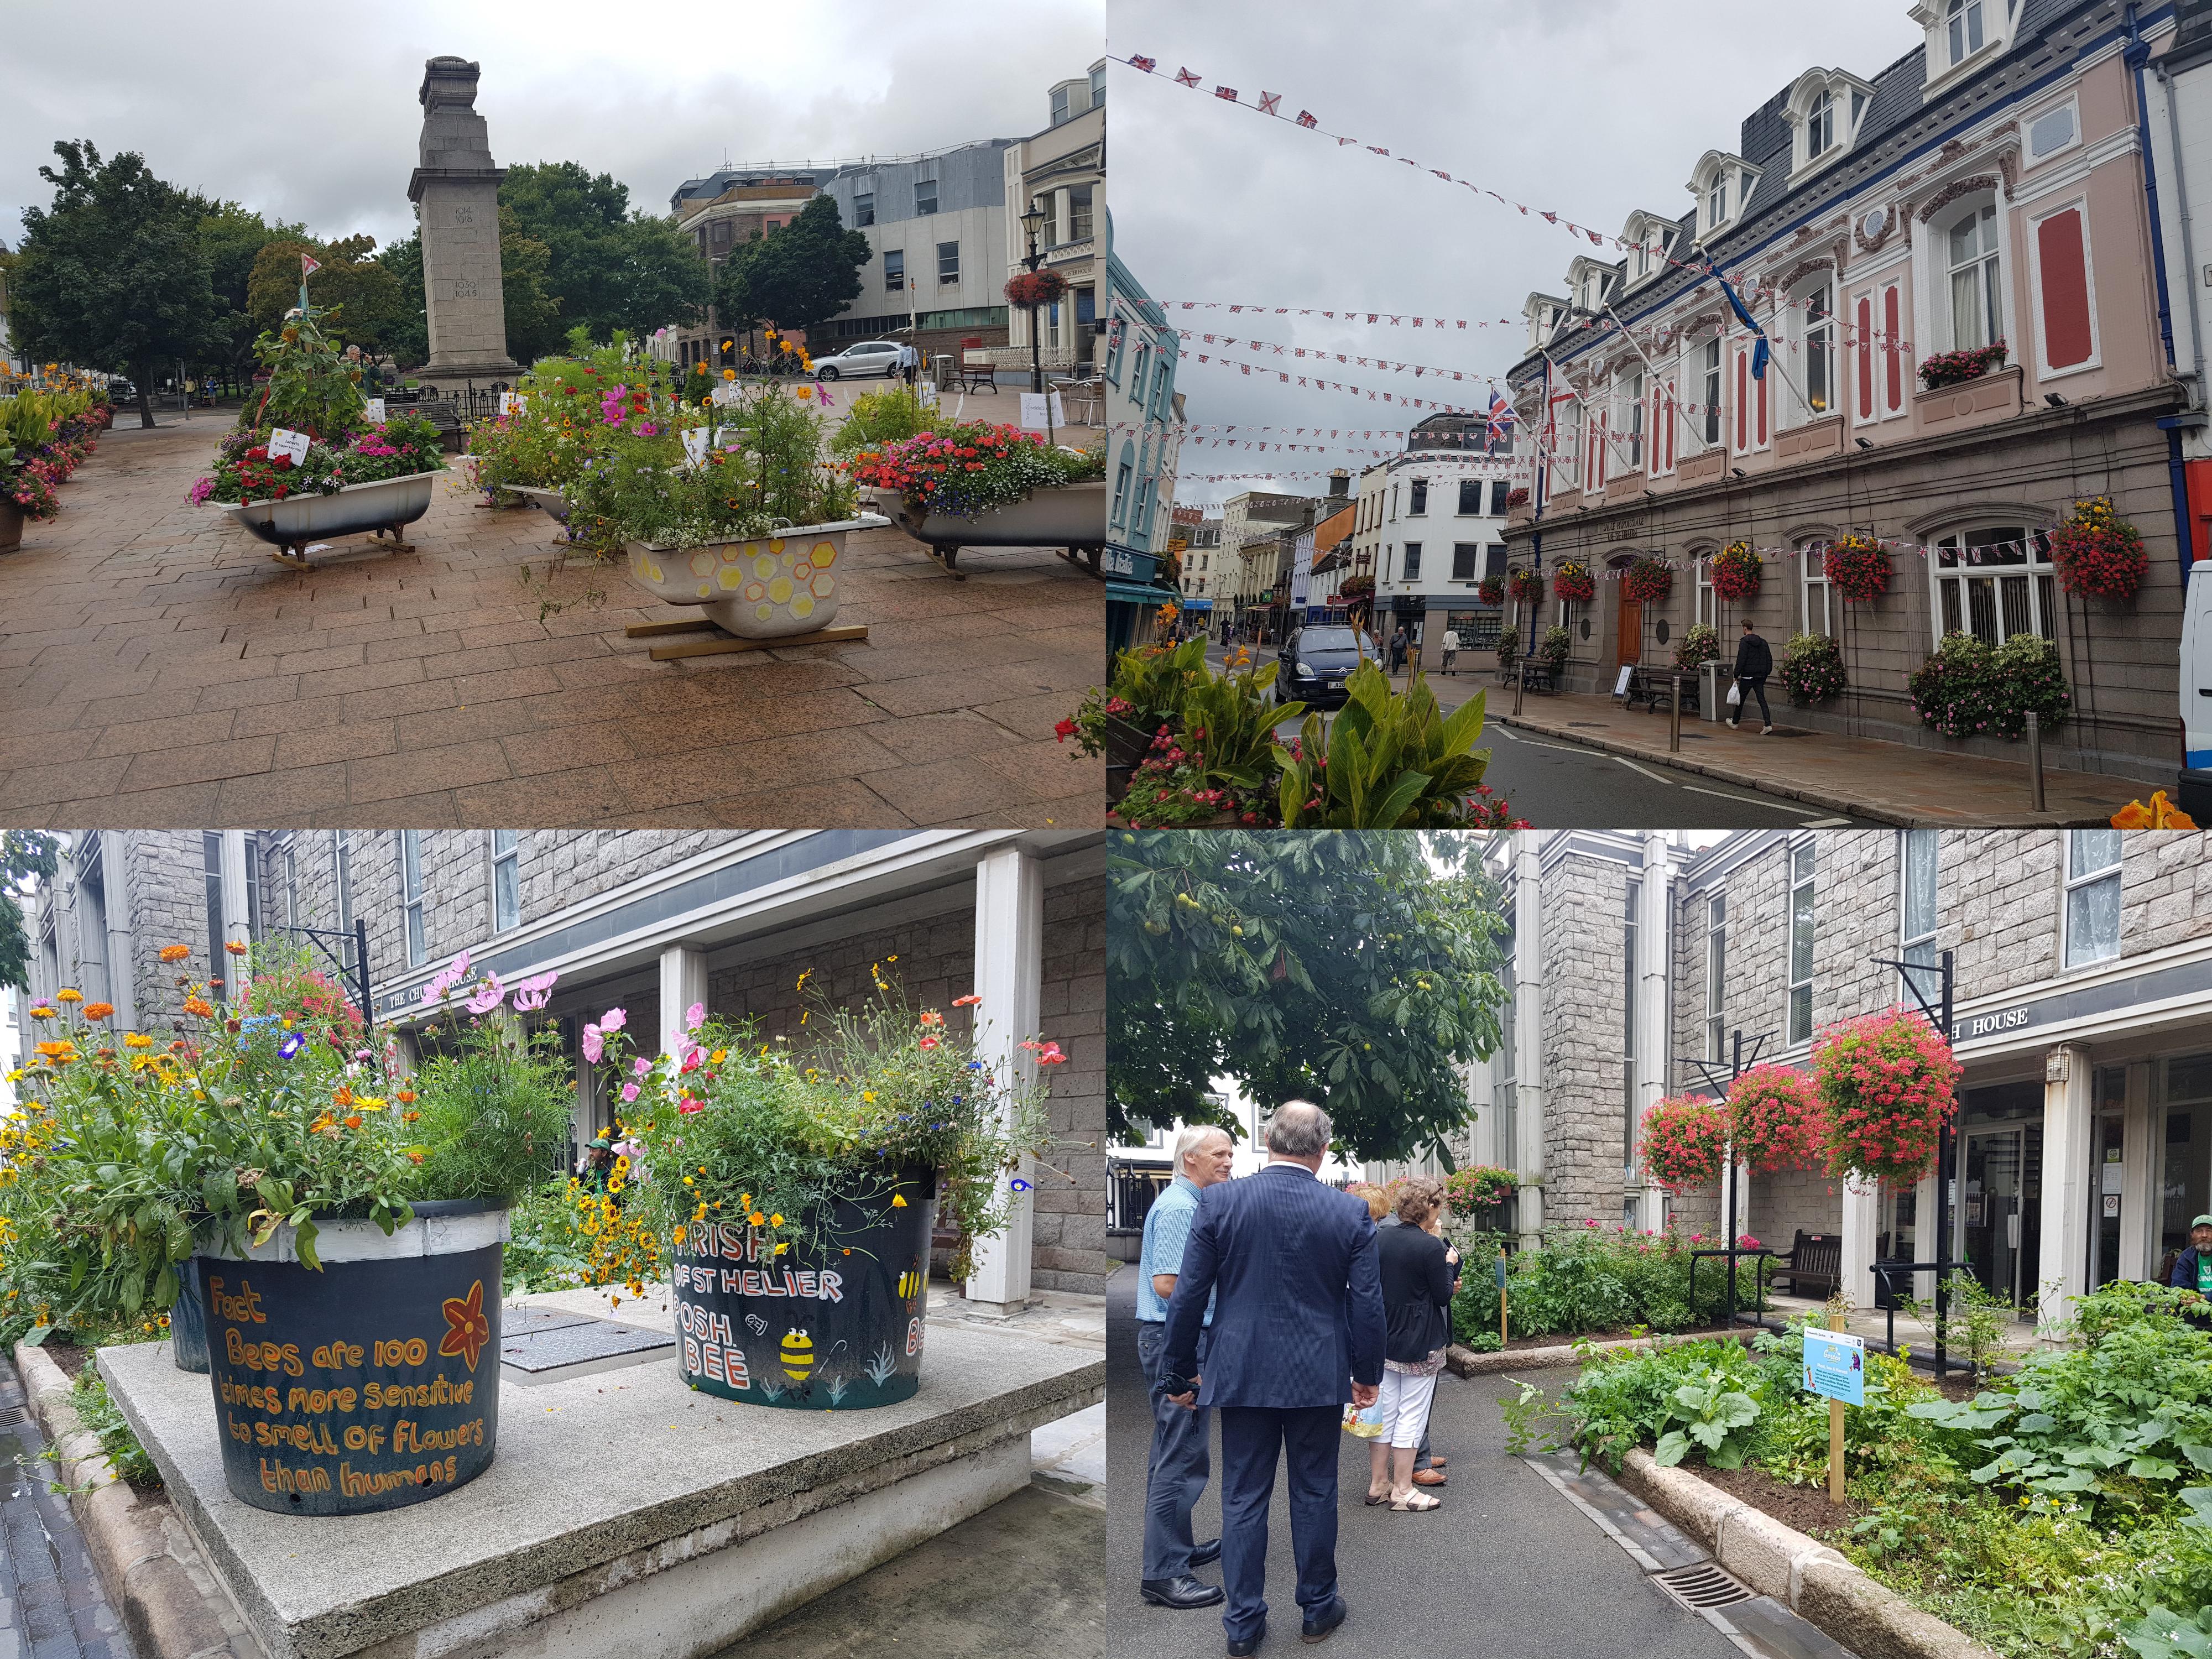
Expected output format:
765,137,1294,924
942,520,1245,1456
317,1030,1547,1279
1106,0,1922,504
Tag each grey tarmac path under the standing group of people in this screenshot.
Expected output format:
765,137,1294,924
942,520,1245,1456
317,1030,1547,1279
1106,1267,1741,1659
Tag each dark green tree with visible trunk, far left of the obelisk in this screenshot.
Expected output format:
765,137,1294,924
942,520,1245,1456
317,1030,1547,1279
9,139,223,427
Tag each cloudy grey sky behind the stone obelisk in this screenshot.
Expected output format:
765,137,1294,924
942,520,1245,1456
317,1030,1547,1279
0,0,1106,246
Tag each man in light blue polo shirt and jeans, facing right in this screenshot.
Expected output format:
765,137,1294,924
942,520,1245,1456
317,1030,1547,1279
1137,1128,1237,1608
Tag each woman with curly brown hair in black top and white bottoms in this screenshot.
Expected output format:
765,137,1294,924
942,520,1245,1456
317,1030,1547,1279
1367,1175,1460,1513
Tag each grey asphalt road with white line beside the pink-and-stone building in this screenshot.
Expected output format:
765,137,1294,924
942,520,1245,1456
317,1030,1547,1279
1208,644,1871,830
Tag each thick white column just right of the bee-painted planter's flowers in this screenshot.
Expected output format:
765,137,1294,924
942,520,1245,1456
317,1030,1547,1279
964,847,1044,1314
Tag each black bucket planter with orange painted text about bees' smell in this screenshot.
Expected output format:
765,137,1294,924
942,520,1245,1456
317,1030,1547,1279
195,1203,507,1515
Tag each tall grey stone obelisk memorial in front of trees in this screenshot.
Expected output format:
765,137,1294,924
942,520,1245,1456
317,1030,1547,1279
407,58,522,392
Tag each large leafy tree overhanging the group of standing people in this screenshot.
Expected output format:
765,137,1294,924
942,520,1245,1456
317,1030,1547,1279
1106,830,1504,1164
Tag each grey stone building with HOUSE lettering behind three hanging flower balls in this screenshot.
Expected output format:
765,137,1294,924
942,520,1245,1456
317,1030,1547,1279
1453,830,2212,1314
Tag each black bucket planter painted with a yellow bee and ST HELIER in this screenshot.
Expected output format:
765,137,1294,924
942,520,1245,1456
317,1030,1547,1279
675,1168,938,1411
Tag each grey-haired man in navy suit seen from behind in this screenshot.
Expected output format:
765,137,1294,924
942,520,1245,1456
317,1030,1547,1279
1159,1099,1383,1655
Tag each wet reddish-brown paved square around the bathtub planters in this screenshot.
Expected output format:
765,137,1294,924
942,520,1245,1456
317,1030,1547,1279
0,418,1104,827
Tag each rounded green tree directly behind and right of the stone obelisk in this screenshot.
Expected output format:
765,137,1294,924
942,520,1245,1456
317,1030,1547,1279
500,161,708,345
